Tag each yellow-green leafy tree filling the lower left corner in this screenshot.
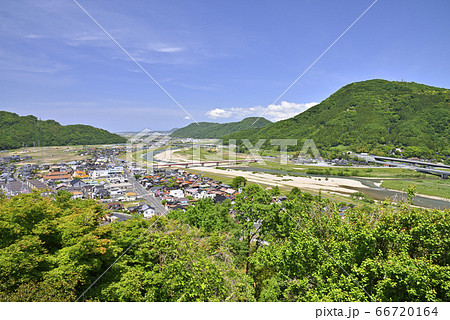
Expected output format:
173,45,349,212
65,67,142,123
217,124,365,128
0,192,110,301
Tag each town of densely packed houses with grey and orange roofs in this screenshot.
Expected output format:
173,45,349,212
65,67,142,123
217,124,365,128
0,147,262,220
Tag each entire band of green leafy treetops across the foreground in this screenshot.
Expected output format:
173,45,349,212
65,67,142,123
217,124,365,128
0,185,450,301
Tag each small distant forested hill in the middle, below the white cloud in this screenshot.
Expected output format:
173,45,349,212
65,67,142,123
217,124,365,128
171,117,272,139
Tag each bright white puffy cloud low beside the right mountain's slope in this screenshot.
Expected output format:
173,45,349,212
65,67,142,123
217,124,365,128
206,101,317,121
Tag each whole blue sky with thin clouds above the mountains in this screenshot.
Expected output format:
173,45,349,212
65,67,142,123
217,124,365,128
0,0,450,132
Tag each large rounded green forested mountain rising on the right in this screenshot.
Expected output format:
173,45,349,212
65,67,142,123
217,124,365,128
225,80,450,156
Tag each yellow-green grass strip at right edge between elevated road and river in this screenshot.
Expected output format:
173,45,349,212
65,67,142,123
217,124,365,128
381,178,450,199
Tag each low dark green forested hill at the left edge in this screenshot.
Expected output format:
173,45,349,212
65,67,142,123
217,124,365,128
0,111,126,150
